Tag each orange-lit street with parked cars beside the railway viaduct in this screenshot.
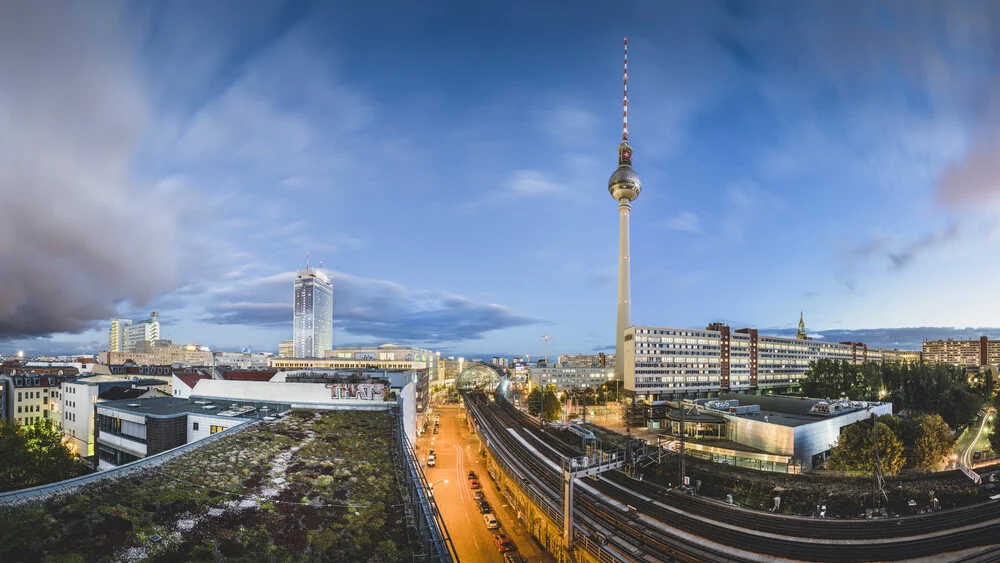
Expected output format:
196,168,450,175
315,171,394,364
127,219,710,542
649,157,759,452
416,405,555,563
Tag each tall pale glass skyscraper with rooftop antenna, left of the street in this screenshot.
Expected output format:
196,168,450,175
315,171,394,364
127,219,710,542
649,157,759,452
292,263,333,358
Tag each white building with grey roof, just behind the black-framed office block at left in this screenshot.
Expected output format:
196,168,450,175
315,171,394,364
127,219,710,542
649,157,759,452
60,375,167,457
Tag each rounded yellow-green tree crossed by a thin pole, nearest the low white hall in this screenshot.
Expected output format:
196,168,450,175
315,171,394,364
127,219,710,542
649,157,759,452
827,421,906,475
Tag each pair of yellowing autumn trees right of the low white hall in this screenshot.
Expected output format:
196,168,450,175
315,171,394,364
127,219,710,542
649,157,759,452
826,414,955,475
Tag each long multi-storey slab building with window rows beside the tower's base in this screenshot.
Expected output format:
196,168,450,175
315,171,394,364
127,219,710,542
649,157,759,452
623,318,919,401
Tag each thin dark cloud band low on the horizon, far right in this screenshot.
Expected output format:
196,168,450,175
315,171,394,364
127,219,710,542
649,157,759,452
761,326,1000,350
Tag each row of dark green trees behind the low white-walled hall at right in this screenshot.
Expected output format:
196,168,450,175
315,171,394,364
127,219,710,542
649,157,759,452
801,359,996,428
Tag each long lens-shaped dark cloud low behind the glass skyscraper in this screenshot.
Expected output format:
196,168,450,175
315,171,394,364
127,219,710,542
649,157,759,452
201,272,540,345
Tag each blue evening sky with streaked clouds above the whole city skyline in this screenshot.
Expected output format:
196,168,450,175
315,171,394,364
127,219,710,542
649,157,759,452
0,0,1000,356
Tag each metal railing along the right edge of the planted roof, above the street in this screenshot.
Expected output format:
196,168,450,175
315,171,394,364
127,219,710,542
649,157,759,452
393,408,458,563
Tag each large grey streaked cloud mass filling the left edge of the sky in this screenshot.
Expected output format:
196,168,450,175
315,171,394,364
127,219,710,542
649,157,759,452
0,1,175,337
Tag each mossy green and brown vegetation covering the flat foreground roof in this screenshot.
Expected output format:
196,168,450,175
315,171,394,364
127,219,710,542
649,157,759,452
0,411,419,562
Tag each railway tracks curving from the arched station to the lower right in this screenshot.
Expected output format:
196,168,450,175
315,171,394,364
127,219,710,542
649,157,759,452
470,390,1000,561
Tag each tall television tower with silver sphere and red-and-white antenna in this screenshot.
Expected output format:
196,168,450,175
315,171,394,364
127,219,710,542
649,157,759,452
608,37,642,379
